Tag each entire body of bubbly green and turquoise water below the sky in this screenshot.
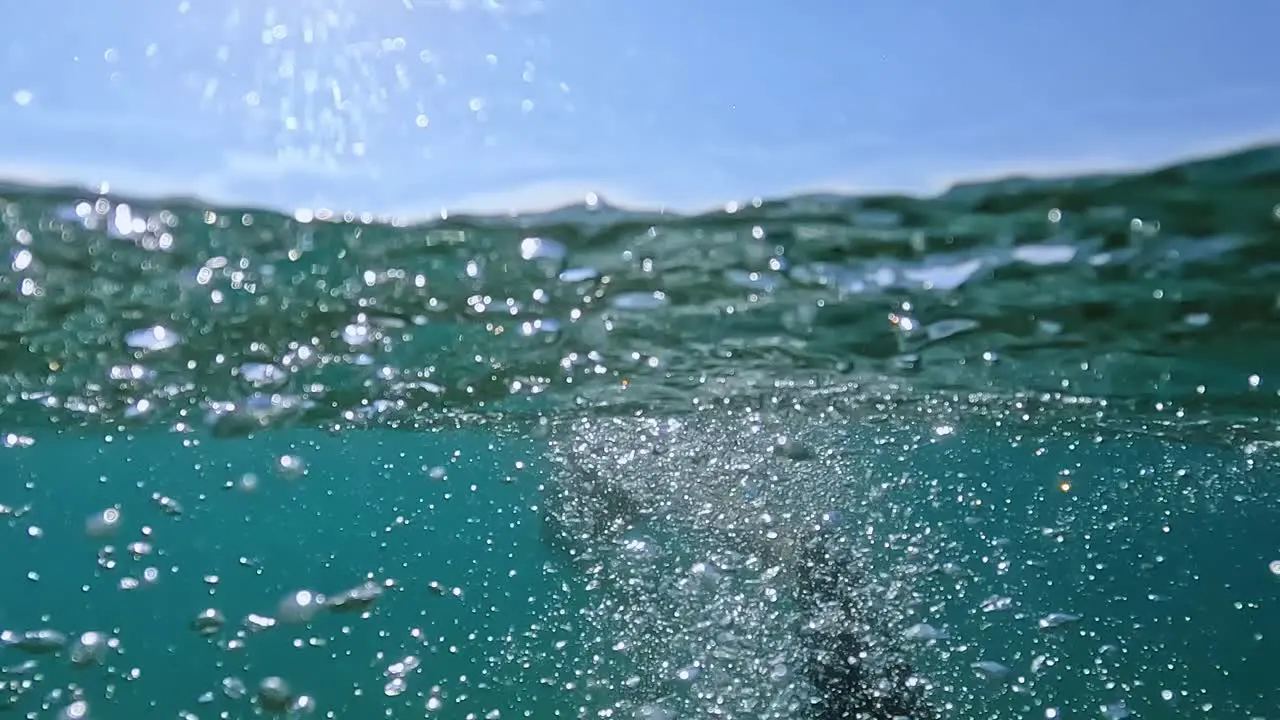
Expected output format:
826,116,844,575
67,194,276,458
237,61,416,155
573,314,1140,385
0,149,1280,719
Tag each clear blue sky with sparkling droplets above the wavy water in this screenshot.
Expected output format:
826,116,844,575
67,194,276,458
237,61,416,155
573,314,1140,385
0,0,1280,215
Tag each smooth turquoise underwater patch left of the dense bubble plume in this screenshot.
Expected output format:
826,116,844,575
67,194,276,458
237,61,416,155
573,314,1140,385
4,429,604,717
